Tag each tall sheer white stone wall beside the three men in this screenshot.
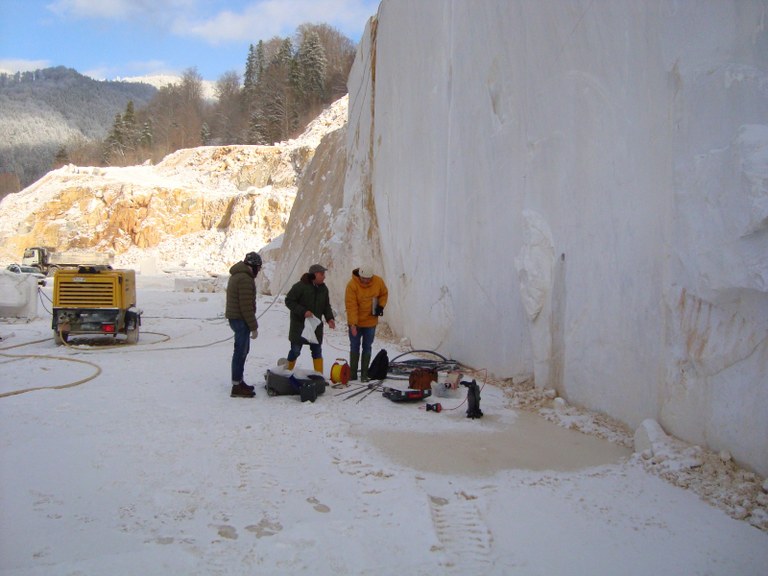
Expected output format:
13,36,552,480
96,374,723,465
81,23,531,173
345,0,768,474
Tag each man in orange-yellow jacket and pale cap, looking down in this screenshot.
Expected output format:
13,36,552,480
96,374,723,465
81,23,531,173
344,265,388,382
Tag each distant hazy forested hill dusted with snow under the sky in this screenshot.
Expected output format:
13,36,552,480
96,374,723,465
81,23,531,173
0,66,157,193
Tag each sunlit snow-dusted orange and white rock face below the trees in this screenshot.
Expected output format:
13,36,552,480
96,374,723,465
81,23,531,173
0,97,347,274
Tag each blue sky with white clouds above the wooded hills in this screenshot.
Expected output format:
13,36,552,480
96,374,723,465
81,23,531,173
0,0,379,80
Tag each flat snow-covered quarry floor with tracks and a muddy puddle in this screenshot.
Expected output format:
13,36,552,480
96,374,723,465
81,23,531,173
0,274,768,576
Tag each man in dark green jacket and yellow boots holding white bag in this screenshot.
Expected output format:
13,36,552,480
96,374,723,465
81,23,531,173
285,264,336,374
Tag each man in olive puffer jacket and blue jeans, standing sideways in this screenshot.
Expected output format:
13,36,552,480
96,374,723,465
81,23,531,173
224,252,261,398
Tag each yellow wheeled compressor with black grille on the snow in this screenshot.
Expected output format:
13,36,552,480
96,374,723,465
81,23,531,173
51,266,142,345
